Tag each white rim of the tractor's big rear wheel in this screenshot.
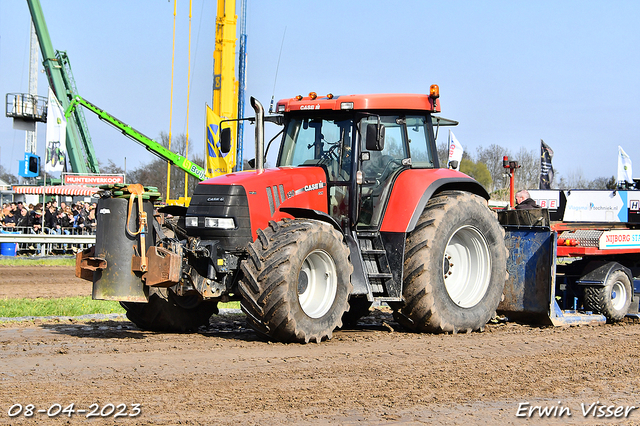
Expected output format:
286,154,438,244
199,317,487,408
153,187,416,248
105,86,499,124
443,225,491,308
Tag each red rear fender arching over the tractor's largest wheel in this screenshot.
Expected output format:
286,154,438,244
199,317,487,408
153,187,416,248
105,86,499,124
380,169,489,232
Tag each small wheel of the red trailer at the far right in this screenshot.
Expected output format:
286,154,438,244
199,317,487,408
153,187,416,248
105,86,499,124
584,269,633,322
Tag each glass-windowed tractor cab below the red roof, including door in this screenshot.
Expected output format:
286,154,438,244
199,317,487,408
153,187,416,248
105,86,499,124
277,99,457,231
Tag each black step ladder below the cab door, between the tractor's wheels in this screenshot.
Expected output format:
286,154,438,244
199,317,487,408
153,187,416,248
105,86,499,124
356,231,400,301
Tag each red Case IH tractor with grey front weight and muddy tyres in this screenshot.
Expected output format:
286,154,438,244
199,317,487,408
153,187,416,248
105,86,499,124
78,85,506,342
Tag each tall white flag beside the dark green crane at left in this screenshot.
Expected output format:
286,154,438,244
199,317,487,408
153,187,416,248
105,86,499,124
44,88,67,173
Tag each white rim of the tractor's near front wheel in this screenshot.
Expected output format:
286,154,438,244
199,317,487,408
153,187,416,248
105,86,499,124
298,250,338,318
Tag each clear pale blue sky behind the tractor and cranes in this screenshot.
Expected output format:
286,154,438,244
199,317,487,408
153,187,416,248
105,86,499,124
0,0,640,179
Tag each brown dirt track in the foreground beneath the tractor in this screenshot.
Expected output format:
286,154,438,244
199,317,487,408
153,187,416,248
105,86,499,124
0,268,640,425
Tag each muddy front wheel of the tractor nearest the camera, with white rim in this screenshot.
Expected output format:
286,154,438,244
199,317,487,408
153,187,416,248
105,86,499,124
239,219,353,343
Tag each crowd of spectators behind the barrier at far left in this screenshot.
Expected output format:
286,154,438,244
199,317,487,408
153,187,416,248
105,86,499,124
0,200,96,234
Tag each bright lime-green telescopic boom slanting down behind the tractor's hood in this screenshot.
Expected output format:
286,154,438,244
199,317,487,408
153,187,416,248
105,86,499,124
65,95,205,180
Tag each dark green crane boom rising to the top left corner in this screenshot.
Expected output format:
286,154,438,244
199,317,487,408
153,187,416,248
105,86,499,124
27,0,100,173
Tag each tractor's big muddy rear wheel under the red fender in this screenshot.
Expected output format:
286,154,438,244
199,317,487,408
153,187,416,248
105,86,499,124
395,191,507,333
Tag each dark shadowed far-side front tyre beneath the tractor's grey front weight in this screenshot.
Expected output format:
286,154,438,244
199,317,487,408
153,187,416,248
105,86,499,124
120,288,218,333
